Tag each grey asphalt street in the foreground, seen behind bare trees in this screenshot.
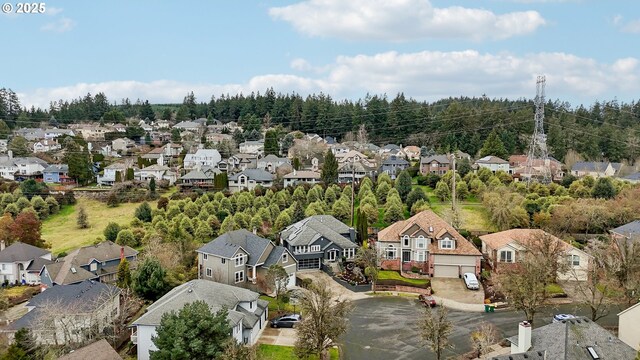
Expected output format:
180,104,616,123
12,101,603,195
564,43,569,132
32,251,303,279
341,297,618,360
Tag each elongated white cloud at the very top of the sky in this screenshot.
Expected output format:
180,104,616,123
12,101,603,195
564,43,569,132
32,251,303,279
269,0,545,41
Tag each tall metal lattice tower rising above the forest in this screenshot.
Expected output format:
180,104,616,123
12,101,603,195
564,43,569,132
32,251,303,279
525,75,551,186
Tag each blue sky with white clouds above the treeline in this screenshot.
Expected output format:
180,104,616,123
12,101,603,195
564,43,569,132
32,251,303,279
0,0,640,108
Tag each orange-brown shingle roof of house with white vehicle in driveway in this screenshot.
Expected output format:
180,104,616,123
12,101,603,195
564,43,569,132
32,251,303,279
378,210,481,256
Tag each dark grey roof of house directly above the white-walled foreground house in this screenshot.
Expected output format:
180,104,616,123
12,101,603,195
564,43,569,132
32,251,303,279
197,229,271,266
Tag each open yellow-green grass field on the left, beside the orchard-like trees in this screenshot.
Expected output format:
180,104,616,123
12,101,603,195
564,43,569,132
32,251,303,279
42,197,155,255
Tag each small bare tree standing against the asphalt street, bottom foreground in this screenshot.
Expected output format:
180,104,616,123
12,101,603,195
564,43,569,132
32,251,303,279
418,306,453,360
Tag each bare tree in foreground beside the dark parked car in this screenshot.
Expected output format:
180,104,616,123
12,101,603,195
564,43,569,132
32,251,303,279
295,282,353,360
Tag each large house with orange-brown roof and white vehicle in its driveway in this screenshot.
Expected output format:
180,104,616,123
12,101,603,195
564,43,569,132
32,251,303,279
376,210,482,278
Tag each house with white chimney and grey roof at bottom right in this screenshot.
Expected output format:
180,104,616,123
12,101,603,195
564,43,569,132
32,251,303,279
492,317,636,360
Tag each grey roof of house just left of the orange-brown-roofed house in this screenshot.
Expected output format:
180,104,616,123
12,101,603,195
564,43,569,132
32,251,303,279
280,215,357,249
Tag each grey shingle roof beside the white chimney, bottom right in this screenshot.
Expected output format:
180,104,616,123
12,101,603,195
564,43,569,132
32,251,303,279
504,317,636,360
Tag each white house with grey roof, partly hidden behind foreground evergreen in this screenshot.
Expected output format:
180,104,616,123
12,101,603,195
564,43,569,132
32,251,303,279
131,279,269,360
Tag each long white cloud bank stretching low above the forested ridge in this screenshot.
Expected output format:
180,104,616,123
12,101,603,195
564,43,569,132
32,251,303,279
20,50,640,107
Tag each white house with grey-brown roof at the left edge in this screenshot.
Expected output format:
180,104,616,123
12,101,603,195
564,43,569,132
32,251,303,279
0,241,53,285
